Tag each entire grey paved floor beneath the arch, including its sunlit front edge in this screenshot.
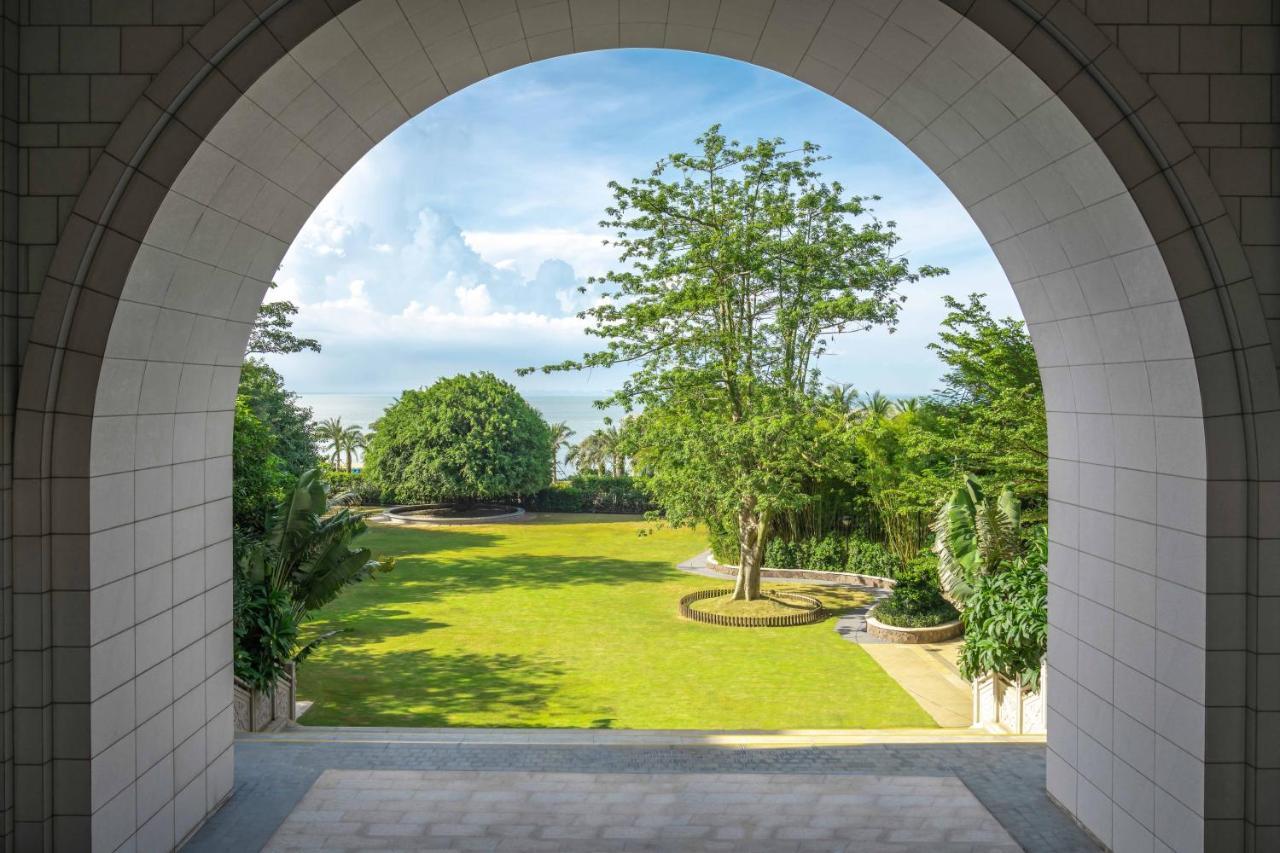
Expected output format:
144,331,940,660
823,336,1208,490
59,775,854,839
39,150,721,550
184,727,1098,853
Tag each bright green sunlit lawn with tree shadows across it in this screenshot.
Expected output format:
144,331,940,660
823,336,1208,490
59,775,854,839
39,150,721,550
300,515,934,729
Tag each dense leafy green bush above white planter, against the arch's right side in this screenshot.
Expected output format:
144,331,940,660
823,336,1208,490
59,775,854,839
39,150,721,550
959,525,1048,690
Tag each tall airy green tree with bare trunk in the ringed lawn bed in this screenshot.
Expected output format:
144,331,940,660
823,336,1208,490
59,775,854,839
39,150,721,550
527,127,941,599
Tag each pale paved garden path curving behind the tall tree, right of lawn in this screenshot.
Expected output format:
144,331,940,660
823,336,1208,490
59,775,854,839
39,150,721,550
677,551,973,727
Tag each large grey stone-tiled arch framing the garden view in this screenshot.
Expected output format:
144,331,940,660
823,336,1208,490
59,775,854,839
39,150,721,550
14,0,1280,850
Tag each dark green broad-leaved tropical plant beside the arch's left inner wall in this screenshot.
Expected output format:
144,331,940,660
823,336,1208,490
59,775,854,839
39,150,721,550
234,469,394,692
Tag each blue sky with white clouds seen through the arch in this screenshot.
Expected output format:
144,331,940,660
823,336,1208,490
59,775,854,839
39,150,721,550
271,50,1020,394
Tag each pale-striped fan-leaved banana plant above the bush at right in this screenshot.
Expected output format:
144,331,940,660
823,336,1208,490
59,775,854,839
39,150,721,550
932,474,1021,608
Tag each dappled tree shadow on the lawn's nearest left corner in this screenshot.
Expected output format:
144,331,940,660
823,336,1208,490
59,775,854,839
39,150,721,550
300,648,563,727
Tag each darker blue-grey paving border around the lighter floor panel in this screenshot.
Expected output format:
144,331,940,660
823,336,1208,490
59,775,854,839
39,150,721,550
183,733,1100,853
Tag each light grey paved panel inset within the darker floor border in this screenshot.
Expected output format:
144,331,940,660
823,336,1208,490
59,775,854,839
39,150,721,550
265,770,1021,853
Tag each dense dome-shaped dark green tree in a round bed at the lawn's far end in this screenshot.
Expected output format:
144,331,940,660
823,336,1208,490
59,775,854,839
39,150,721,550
365,373,552,502
